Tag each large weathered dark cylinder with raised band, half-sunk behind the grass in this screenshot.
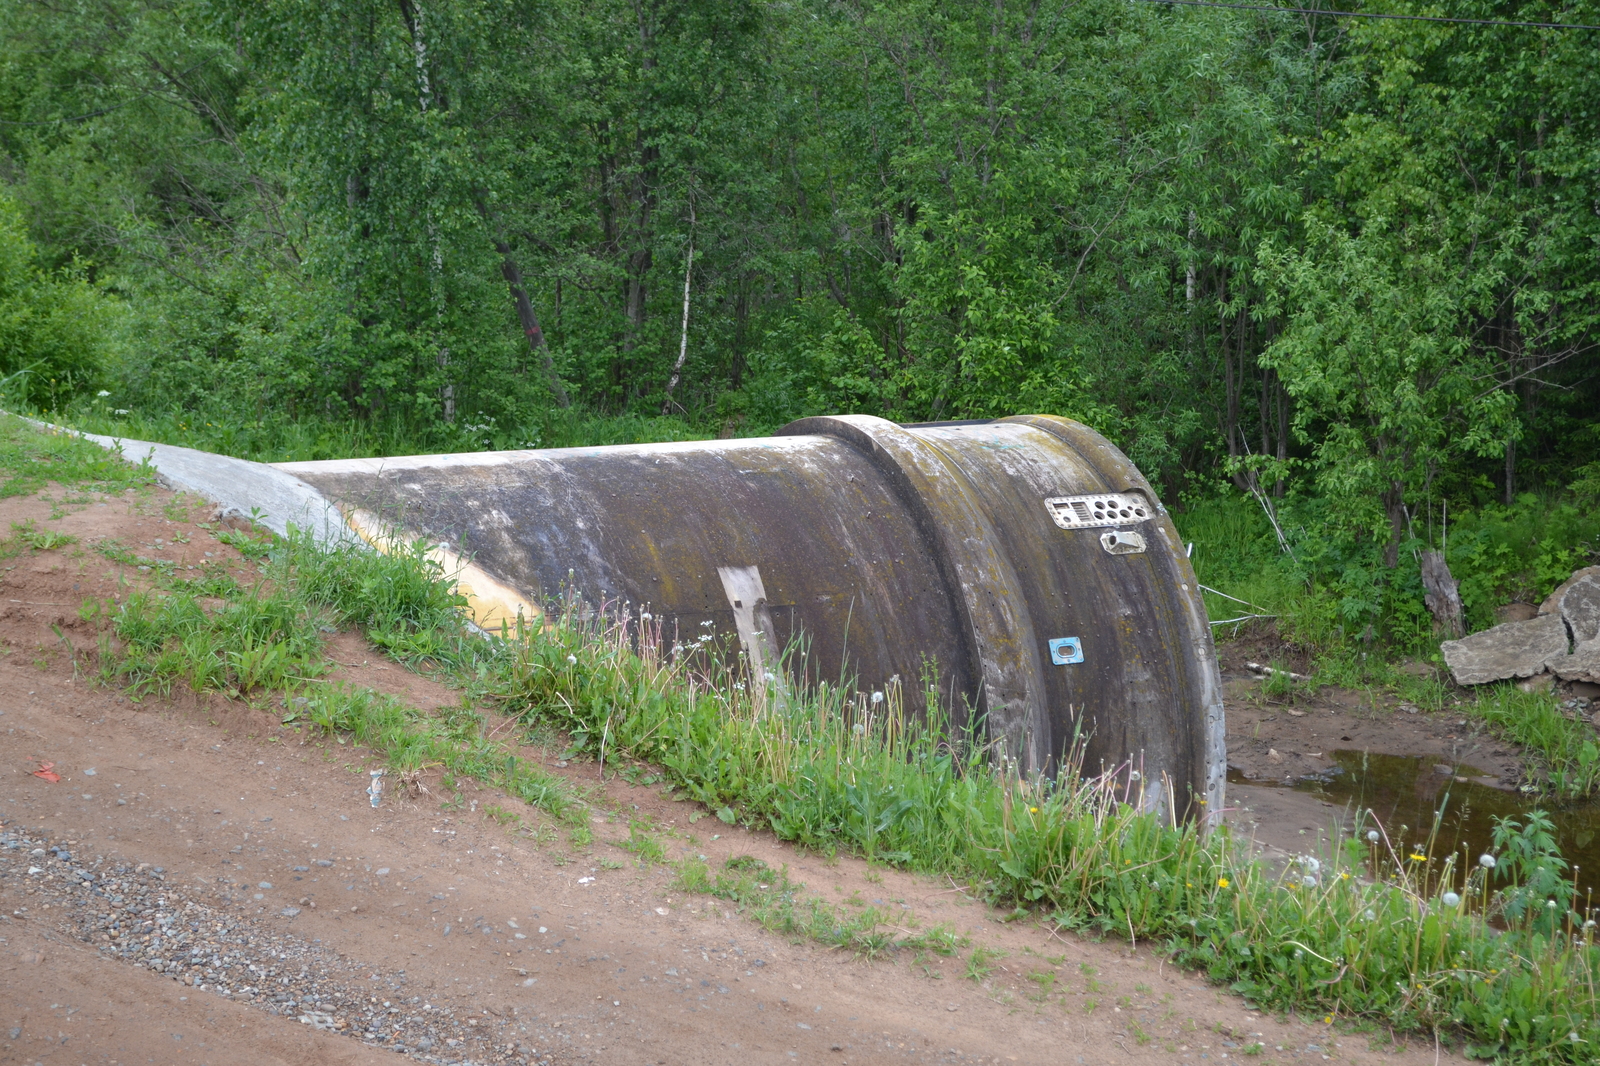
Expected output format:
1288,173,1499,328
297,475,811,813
278,415,1226,821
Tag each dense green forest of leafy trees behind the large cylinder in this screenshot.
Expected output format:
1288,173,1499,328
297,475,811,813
0,0,1600,643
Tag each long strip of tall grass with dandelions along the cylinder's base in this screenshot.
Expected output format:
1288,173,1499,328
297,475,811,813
489,589,1600,1061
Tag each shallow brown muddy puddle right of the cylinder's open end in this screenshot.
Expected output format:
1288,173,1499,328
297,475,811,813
1229,751,1600,898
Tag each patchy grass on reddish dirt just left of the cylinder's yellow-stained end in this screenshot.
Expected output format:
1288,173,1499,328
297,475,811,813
83,521,586,823
